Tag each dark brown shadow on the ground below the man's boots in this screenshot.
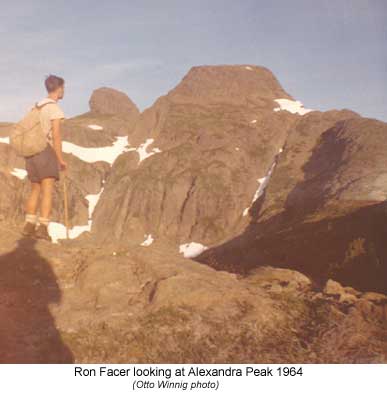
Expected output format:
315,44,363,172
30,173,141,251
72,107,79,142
0,238,74,363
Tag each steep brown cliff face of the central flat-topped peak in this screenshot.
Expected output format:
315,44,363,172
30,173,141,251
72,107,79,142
92,66,301,245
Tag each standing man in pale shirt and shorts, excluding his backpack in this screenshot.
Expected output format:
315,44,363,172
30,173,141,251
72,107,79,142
22,75,67,241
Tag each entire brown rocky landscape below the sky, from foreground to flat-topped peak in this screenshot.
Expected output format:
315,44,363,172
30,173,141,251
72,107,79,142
0,65,387,363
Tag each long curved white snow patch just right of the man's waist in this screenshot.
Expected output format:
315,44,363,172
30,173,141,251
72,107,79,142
62,136,130,165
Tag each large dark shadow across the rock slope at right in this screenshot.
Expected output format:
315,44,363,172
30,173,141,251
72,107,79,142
195,122,387,293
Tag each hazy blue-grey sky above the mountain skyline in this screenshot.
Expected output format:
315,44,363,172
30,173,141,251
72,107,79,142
0,0,387,121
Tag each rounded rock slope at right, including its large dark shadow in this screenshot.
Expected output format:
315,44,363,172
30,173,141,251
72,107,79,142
198,111,387,292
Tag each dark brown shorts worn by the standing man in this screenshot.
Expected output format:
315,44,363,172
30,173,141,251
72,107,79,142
25,144,59,182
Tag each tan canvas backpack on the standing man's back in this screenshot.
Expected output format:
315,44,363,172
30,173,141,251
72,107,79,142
9,102,51,157
